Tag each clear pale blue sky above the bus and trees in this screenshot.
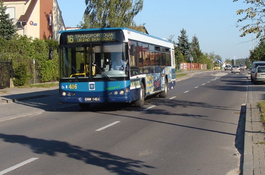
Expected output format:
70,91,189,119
57,0,254,61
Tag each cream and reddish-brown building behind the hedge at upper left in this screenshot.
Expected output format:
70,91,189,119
3,0,65,40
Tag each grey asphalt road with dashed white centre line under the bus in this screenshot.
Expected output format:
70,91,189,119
0,72,249,175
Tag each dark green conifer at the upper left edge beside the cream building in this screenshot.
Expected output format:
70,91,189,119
0,0,16,40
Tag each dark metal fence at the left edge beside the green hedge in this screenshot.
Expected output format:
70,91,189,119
0,60,13,89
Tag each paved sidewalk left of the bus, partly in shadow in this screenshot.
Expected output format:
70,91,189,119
0,87,60,122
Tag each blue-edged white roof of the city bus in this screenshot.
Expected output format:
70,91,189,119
59,27,173,49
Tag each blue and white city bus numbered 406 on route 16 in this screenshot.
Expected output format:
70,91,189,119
59,28,175,108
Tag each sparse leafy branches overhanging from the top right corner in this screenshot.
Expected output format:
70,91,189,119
233,0,265,38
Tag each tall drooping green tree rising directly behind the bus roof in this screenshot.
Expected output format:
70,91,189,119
81,0,143,28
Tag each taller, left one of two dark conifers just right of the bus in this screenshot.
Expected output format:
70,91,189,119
178,29,191,62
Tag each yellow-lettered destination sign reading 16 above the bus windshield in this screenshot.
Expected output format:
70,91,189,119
67,32,116,44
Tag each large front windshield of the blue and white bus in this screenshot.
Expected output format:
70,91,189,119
60,43,128,81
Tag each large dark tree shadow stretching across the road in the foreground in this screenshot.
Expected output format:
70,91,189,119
0,133,155,175
